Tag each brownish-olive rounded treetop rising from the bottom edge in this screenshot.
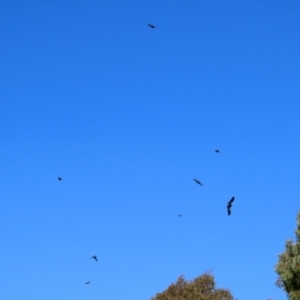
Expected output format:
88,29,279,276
151,272,234,300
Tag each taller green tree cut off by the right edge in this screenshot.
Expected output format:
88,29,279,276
275,212,300,300
